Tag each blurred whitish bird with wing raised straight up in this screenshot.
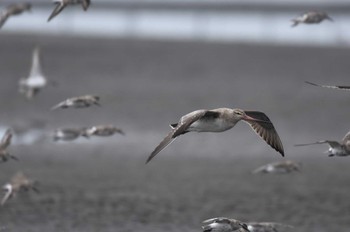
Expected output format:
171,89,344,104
18,47,47,99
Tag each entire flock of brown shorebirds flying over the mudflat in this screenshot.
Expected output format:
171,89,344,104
0,0,350,232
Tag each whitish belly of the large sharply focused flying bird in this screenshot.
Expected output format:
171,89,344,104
188,119,234,132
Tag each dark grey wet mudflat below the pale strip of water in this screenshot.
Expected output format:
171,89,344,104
0,35,350,232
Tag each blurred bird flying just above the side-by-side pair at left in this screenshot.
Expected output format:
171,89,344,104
51,95,100,110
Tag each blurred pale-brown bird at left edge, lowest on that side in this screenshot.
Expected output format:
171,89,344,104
1,172,39,205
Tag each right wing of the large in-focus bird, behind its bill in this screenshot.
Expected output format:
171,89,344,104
244,111,284,156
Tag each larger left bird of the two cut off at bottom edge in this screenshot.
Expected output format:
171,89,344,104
202,217,250,232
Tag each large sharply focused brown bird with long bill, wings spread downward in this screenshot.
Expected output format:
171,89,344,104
146,108,284,163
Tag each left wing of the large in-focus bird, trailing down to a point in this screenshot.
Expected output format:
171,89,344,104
146,110,207,163
